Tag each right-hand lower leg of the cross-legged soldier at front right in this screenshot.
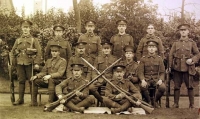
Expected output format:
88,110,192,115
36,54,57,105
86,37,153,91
111,101,131,114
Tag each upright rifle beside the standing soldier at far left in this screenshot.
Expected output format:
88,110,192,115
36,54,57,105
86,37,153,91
8,53,15,103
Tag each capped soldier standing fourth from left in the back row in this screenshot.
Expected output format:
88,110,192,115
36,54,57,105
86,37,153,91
110,20,134,58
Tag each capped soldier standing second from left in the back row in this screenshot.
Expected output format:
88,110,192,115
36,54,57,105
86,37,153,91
45,24,72,61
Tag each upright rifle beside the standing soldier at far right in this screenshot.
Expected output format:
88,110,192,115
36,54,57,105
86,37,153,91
165,49,170,108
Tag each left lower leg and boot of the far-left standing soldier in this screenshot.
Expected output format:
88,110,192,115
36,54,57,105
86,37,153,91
13,84,25,105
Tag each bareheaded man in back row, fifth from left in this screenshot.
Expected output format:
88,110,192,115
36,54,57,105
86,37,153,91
136,24,164,63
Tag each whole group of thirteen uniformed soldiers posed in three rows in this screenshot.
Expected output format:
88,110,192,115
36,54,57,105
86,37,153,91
11,20,200,113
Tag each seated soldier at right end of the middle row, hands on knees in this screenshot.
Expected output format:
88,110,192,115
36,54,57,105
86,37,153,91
138,41,166,108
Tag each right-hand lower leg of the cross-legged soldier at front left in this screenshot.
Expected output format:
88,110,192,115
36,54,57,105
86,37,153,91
76,95,95,108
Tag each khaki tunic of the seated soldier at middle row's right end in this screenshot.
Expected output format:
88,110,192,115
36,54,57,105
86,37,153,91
138,55,165,82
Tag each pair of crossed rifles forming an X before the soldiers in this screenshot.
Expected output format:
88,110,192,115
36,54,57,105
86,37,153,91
44,57,154,113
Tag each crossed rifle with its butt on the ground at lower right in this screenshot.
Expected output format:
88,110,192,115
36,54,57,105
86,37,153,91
81,57,154,113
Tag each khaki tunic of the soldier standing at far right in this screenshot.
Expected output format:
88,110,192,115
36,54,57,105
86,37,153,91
169,38,200,72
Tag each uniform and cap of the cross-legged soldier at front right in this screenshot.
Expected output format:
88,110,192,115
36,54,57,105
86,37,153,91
103,65,141,113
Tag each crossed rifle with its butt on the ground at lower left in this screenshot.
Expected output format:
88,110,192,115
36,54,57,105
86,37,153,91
44,58,121,112
